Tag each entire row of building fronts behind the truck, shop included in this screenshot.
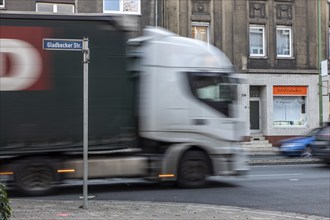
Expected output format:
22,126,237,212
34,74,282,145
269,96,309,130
0,0,330,144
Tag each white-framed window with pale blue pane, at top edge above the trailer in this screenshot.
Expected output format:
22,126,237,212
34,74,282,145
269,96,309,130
103,0,141,14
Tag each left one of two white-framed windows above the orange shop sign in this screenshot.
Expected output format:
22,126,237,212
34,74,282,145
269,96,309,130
250,25,266,57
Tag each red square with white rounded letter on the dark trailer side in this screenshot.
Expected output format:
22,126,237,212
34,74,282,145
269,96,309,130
0,26,52,91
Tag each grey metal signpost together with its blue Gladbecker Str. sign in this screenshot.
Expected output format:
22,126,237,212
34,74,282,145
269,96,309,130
42,37,90,209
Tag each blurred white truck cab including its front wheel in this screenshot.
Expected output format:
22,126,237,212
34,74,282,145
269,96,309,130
128,28,248,187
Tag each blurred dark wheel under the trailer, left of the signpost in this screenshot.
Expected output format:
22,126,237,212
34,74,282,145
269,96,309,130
15,158,58,196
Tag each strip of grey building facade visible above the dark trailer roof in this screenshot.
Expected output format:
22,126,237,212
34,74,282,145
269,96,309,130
0,0,160,36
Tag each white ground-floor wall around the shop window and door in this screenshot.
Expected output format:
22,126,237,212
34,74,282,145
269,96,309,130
239,73,329,136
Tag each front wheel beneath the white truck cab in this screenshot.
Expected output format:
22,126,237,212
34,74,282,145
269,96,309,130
178,151,211,188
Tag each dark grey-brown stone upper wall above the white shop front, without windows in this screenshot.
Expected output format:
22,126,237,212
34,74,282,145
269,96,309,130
163,0,329,70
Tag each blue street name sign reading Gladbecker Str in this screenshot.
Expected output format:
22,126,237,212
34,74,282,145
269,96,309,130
42,38,83,51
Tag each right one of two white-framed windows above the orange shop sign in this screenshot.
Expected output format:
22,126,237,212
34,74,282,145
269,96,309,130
276,26,292,57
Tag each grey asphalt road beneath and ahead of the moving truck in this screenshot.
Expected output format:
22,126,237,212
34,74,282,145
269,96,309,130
9,164,330,218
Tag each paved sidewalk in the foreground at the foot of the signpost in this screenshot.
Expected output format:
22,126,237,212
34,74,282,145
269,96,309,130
11,199,329,220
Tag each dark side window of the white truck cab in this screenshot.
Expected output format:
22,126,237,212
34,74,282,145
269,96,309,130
188,72,237,117
